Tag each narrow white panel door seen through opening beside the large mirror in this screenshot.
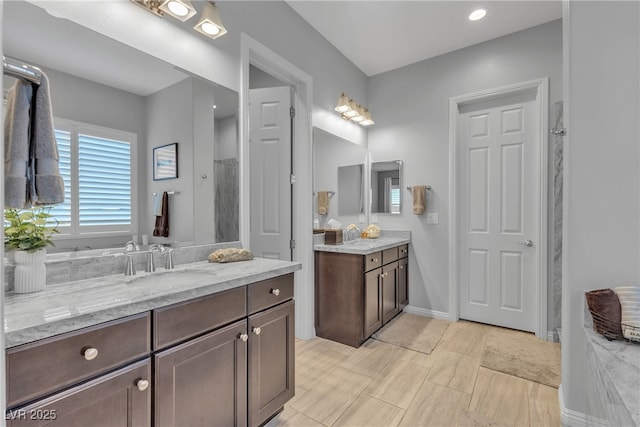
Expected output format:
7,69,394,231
249,86,291,260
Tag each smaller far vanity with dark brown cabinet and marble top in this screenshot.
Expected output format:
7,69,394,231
314,237,409,347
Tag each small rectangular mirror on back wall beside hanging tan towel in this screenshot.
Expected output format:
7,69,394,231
371,160,402,214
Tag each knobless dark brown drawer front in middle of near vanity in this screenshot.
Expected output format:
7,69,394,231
153,286,247,350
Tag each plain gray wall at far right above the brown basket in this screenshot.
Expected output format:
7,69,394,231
562,1,640,413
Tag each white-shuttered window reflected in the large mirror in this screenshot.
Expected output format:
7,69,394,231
51,119,137,238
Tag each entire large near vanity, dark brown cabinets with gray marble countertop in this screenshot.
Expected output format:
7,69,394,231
5,259,301,426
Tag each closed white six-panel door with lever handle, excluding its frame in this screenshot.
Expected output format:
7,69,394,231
459,93,540,332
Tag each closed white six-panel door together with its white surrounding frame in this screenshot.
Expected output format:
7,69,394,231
449,79,548,339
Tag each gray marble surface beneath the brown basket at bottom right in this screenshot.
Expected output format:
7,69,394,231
585,327,640,425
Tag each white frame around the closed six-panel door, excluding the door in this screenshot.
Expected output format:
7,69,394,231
449,77,549,340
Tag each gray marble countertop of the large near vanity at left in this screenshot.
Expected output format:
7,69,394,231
4,258,302,348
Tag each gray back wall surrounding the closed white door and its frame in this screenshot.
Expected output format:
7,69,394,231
369,20,562,328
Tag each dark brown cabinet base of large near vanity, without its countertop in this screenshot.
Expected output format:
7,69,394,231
5,274,295,427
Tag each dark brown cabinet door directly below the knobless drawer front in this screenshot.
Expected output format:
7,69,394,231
154,320,247,427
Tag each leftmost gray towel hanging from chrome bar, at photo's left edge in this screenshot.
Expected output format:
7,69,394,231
4,80,33,209
